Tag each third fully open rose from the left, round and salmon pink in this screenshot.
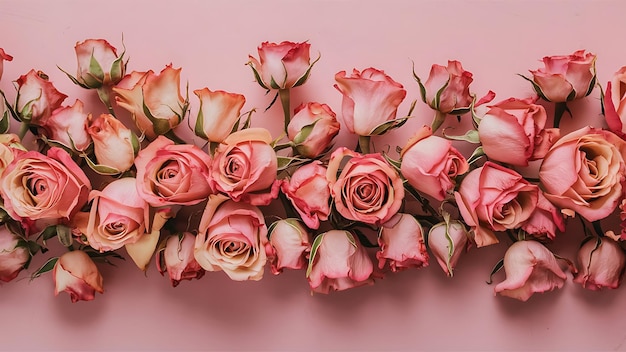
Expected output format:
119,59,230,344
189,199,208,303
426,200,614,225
135,136,213,207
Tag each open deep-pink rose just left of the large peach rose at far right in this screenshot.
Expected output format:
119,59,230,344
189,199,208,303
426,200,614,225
454,161,539,247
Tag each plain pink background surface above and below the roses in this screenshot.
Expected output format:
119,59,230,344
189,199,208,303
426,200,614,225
0,0,626,350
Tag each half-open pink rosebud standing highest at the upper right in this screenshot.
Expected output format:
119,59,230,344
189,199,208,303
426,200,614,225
529,50,596,103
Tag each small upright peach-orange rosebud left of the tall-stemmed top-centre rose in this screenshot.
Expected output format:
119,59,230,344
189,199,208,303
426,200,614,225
193,88,246,143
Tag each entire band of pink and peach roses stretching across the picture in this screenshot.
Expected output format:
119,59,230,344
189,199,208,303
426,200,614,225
0,39,626,302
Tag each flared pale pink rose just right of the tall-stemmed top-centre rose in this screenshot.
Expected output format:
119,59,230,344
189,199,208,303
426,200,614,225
335,67,406,136
